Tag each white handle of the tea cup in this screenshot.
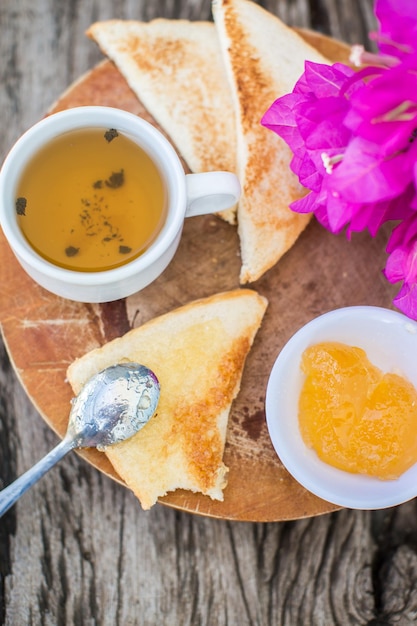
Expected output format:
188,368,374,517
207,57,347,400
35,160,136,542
185,172,241,217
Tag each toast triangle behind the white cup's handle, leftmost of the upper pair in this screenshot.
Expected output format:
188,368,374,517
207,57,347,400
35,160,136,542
87,18,236,224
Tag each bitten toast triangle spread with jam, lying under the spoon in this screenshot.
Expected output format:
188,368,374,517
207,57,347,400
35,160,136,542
67,289,267,509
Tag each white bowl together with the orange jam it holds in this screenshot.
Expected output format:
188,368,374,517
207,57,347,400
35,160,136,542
265,306,417,510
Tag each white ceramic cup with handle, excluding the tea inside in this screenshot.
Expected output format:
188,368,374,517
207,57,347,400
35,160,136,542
0,106,240,302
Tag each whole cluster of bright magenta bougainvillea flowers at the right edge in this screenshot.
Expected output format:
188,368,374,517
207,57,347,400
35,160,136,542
261,0,417,319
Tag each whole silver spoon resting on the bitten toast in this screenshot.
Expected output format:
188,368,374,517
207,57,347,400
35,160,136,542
0,363,159,517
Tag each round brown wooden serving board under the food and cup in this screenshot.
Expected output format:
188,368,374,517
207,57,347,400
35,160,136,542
0,32,395,522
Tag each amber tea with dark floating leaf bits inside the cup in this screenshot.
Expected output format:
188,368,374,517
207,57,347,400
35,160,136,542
16,128,166,271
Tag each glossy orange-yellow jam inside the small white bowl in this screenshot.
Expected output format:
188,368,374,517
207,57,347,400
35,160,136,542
298,342,417,480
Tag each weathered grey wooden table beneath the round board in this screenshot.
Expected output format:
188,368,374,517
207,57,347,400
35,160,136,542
0,0,417,626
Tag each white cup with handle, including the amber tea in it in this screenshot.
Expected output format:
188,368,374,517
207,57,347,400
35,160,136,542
0,106,240,302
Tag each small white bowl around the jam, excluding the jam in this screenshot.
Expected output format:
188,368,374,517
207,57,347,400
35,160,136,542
266,306,417,509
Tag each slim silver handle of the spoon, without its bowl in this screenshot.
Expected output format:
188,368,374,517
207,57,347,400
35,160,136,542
0,439,74,517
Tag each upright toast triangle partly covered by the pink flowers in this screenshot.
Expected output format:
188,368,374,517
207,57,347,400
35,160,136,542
212,0,328,284
